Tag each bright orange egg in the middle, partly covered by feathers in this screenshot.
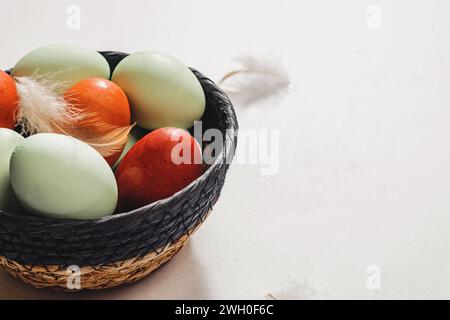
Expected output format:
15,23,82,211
64,78,131,166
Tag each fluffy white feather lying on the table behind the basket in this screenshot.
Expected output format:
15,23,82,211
219,55,290,105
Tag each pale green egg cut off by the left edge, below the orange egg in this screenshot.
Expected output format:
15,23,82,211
0,128,24,211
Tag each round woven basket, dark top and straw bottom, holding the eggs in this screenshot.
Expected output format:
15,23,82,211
0,51,238,291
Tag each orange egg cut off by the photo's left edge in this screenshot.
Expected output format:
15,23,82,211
0,70,19,129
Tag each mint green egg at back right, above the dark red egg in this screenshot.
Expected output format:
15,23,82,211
112,51,205,129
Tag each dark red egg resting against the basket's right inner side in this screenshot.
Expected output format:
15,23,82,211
116,128,203,212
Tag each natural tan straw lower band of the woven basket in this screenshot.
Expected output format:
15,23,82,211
0,235,189,292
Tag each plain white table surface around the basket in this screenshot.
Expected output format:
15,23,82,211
0,0,450,299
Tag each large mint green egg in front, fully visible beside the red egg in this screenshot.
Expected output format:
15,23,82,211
10,133,118,219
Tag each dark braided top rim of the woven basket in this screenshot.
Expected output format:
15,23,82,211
0,51,239,227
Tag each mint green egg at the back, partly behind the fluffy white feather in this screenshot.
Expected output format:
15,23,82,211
11,44,110,89
